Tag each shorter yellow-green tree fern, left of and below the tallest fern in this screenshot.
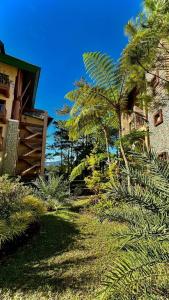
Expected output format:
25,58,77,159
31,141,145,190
66,81,117,169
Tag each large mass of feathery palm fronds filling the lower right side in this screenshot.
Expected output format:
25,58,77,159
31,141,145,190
99,153,169,300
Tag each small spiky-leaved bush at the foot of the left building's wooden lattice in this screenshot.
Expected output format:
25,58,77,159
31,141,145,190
35,173,69,207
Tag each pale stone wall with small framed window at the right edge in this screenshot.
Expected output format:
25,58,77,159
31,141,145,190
146,41,169,159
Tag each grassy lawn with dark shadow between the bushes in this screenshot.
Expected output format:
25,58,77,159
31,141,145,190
0,199,127,300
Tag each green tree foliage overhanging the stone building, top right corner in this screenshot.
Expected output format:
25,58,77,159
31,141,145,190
122,0,169,86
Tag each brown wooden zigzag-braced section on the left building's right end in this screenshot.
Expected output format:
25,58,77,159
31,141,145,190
17,110,47,177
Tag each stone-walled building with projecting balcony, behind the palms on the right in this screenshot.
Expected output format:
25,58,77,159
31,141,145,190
122,41,169,159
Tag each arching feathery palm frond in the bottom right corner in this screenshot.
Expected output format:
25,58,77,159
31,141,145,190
104,241,169,300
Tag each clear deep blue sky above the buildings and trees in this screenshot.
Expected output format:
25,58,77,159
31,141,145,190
0,0,141,122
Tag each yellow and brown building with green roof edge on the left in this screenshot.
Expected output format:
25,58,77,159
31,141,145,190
0,42,52,178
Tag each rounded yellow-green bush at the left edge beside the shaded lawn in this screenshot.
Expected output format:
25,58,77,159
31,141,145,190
0,176,45,248
